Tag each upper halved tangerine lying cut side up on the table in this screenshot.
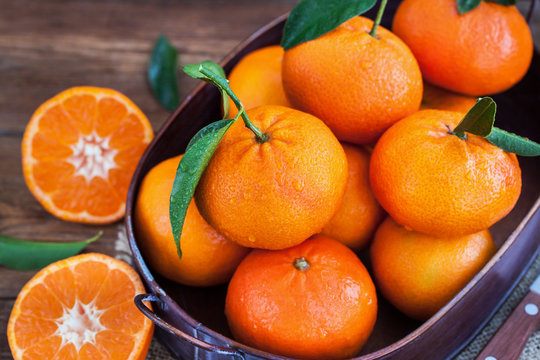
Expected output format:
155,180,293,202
22,86,154,224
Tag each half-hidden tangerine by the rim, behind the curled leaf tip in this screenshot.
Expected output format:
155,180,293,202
228,45,291,118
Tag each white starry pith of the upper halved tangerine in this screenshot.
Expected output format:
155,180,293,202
67,132,118,181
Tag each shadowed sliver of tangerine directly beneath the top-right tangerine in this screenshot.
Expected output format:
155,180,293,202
420,82,476,114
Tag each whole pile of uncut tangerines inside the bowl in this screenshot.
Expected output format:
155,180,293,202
135,0,533,359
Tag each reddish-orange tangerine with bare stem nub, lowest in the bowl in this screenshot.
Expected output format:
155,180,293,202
225,235,377,359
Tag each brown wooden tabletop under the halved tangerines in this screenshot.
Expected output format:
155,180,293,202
0,0,296,359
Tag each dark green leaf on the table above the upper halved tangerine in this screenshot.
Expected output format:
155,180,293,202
148,35,180,111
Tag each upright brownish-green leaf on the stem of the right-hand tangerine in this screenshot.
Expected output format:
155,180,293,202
453,97,497,139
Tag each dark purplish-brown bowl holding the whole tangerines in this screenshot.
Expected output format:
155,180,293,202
125,1,540,360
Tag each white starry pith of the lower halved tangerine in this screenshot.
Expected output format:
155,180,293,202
55,300,106,352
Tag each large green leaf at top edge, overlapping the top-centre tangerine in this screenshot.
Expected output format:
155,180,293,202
281,0,377,50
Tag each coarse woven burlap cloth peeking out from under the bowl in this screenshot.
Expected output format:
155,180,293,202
115,227,540,360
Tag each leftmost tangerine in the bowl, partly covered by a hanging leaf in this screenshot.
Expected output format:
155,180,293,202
135,155,249,286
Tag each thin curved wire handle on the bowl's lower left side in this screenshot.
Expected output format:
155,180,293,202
134,294,244,360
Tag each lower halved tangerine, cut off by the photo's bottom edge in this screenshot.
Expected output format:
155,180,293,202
7,253,153,360
